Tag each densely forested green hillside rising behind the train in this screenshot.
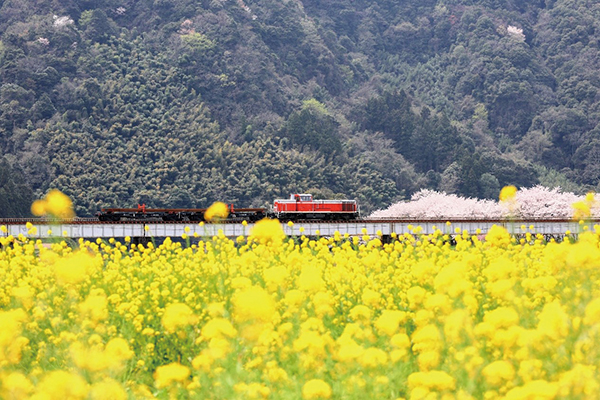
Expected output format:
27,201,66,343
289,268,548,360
0,0,600,217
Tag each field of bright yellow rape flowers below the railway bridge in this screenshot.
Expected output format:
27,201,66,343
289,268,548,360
0,220,600,400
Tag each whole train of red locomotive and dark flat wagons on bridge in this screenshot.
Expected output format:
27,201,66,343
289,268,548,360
96,193,360,222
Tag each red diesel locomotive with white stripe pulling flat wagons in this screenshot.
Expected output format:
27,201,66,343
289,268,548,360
273,194,360,221
